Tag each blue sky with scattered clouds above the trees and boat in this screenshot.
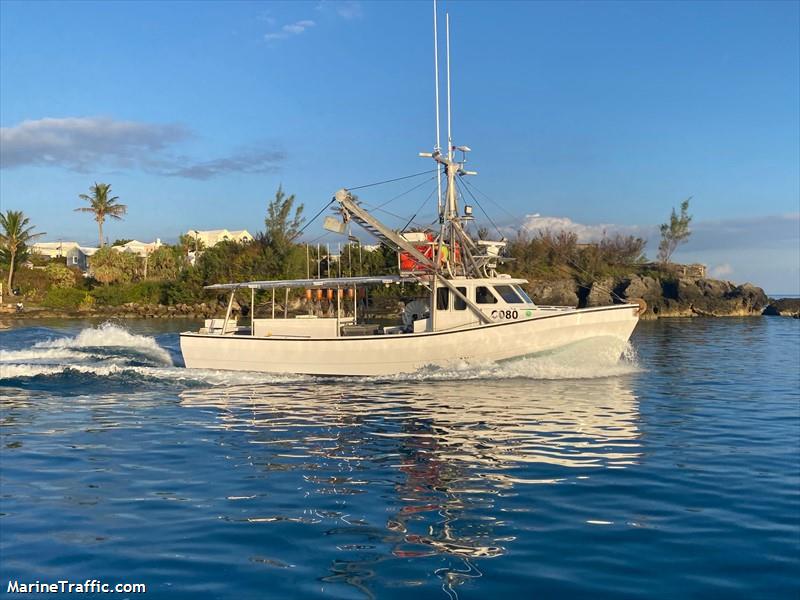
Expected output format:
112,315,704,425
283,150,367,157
0,1,800,293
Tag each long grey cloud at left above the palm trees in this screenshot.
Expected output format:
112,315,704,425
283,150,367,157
0,117,285,179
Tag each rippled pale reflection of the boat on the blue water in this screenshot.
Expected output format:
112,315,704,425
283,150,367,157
175,378,641,593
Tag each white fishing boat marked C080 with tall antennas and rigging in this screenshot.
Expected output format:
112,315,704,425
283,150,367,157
180,4,640,376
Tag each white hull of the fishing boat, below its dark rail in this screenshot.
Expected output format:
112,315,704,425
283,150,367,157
180,304,639,376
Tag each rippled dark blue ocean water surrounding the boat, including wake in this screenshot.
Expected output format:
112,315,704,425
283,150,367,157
0,318,800,599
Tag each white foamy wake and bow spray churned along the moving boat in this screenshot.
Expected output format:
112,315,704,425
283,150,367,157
0,323,640,393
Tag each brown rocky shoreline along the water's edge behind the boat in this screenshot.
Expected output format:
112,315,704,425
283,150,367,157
0,275,800,322
